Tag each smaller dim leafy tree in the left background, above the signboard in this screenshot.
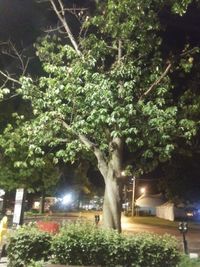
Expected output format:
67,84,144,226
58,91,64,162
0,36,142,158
0,150,60,213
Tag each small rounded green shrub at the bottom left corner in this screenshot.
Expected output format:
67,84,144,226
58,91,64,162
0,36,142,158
7,225,52,267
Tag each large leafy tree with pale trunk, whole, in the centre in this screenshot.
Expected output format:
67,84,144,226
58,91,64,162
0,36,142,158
1,0,197,231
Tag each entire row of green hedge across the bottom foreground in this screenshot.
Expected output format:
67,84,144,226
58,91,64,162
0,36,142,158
7,223,180,267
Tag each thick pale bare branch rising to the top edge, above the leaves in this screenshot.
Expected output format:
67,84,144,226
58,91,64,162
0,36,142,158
50,0,81,55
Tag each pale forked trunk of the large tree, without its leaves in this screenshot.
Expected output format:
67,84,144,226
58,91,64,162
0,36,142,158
76,130,124,232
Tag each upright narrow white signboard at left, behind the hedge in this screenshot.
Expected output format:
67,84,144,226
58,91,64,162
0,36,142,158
13,188,24,224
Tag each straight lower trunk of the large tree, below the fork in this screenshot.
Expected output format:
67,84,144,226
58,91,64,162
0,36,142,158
103,170,121,233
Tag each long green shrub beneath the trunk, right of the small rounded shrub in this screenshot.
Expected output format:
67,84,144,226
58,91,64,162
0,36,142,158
52,224,180,267
